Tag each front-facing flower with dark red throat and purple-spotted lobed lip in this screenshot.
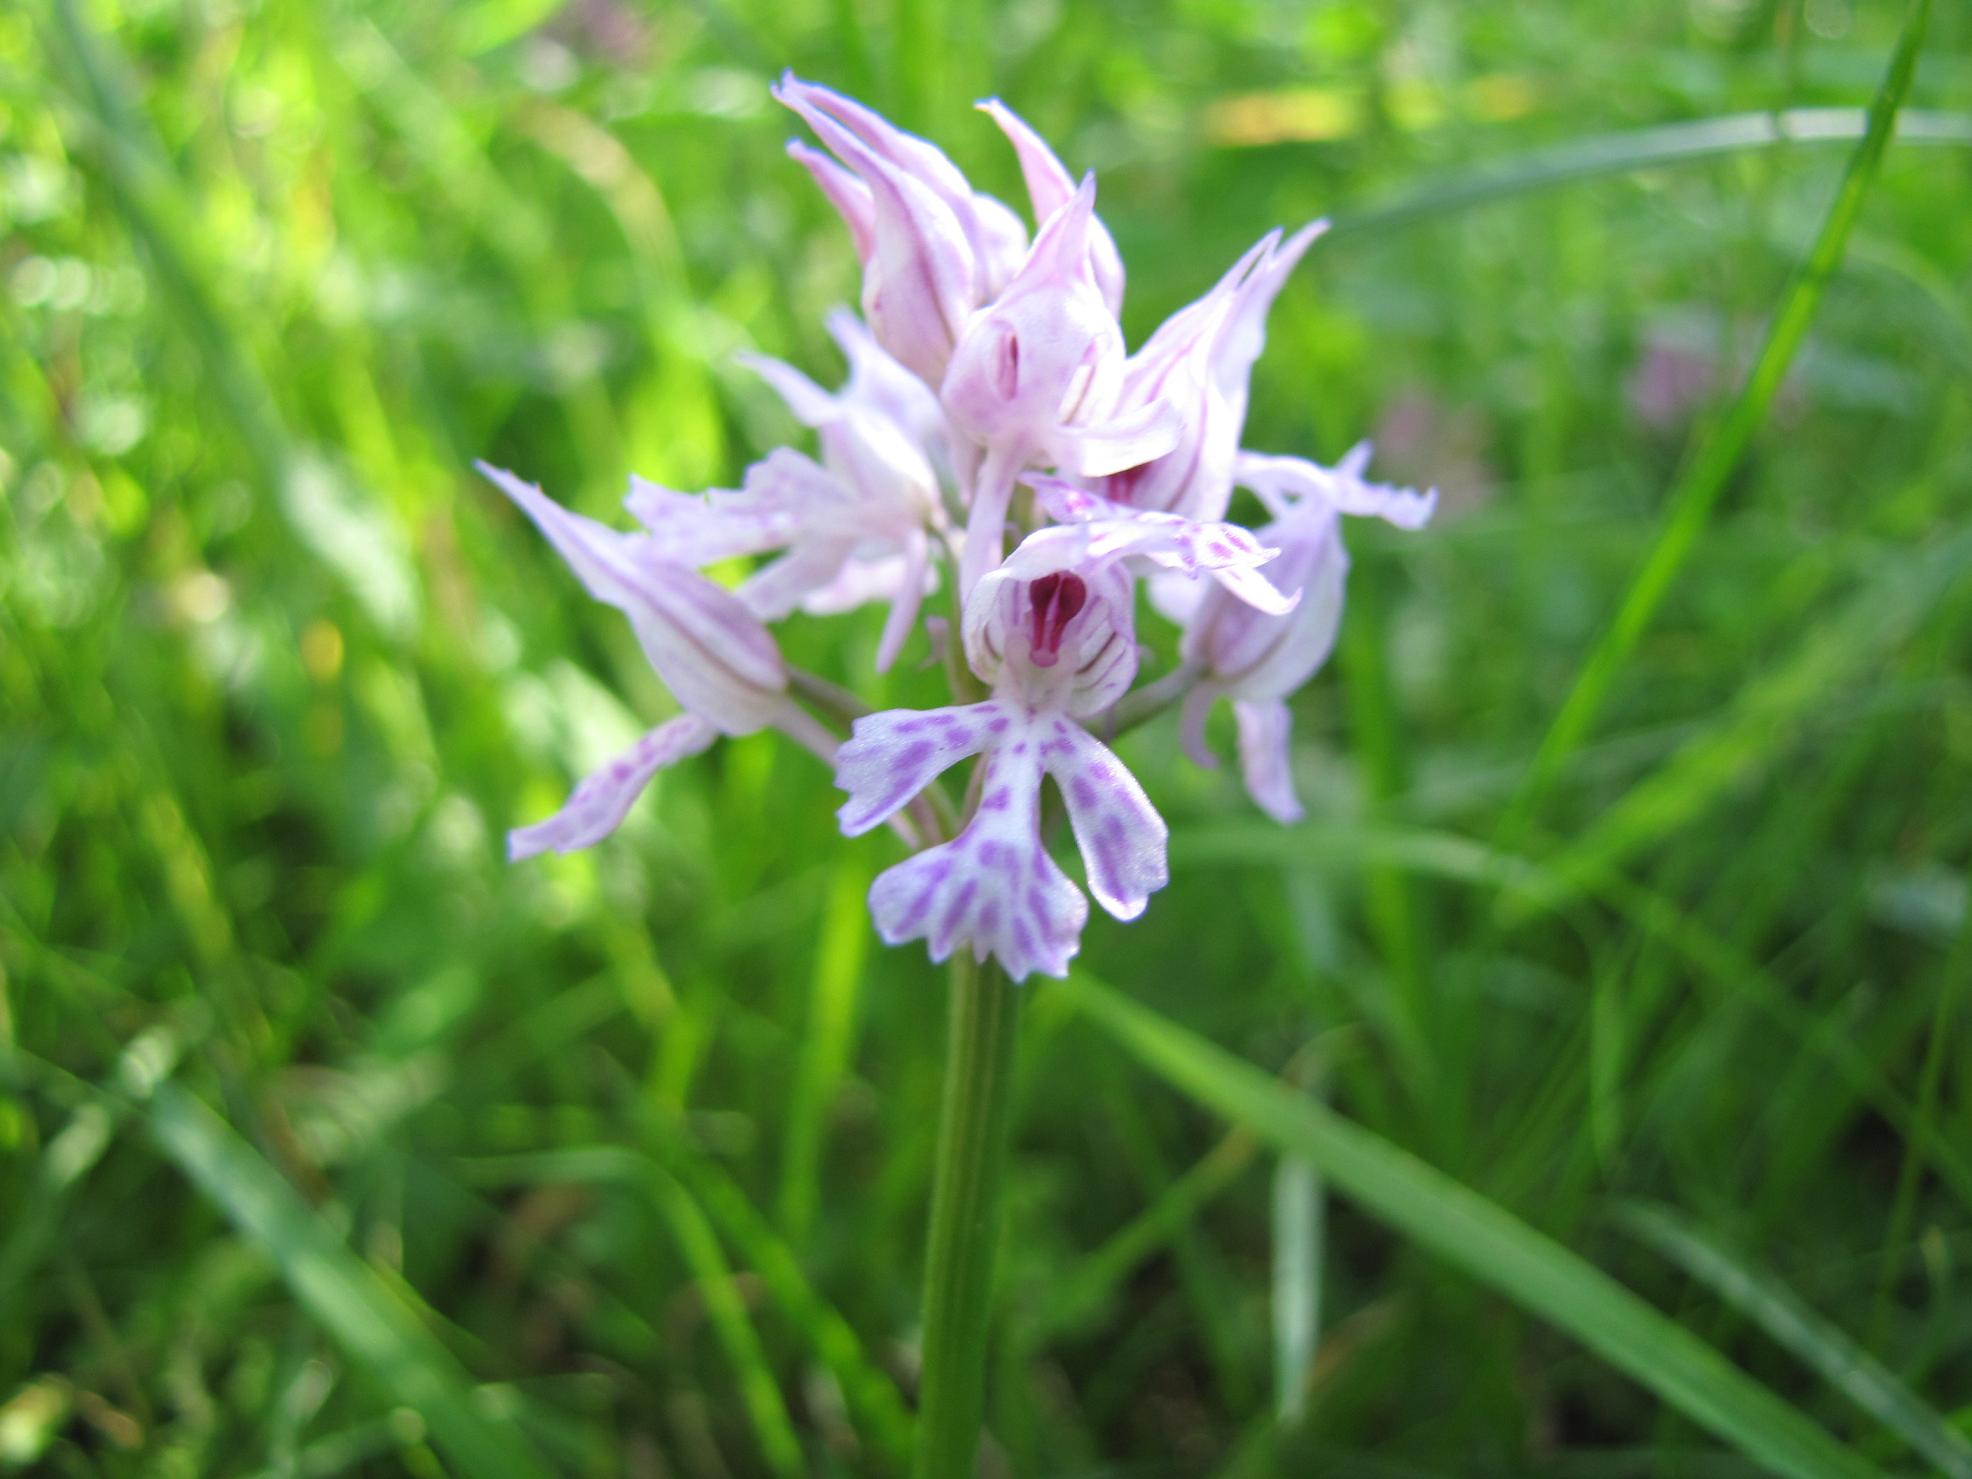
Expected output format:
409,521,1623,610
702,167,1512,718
836,546,1169,980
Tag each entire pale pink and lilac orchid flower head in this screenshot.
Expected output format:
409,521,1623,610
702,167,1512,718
481,75,1436,980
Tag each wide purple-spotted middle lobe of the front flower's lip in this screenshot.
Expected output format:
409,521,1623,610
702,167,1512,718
870,745,1089,980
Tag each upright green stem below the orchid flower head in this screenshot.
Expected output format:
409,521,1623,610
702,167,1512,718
913,952,1021,1479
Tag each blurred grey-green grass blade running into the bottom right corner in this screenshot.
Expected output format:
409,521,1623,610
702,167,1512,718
1617,1203,1972,1479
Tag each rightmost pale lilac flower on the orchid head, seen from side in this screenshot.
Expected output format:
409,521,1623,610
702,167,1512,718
1165,444,1438,822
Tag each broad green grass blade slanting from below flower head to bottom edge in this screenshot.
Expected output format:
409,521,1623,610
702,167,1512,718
1051,974,1875,1479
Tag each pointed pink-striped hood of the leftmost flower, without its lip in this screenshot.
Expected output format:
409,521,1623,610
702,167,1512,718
477,461,787,734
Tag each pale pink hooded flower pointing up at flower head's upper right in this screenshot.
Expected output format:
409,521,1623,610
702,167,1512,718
1089,221,1327,519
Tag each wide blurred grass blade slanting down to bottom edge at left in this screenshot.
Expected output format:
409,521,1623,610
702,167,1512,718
144,1085,550,1479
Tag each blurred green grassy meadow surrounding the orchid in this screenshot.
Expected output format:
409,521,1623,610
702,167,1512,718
0,0,1972,1479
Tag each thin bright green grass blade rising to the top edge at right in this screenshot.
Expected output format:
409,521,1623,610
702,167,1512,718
1501,0,1931,852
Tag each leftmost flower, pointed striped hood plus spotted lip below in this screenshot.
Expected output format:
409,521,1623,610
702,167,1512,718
477,461,809,858
